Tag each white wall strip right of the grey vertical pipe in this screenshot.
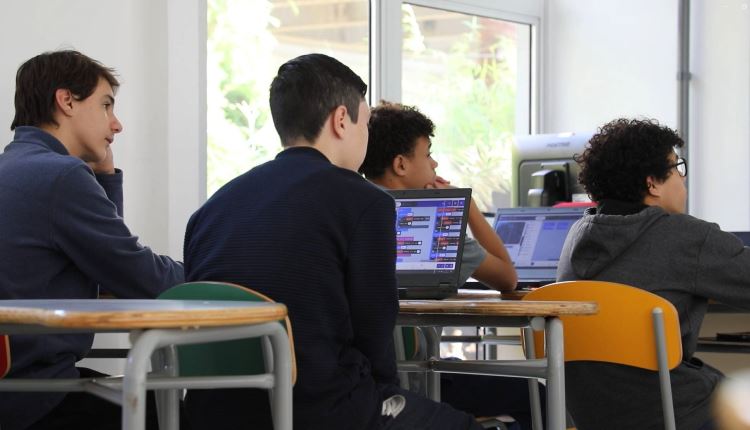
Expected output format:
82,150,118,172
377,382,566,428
688,0,750,231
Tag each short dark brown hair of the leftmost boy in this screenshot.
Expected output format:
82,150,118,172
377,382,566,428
10,50,120,130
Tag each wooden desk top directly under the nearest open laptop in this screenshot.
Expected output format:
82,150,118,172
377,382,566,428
399,299,599,317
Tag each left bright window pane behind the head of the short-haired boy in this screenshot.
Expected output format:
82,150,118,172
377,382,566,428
206,0,369,196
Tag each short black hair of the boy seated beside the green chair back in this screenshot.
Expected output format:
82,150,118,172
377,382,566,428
270,54,367,146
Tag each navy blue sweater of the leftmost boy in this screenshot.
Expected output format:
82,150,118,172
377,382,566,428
0,127,184,430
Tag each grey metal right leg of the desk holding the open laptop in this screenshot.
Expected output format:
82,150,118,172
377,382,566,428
545,317,565,430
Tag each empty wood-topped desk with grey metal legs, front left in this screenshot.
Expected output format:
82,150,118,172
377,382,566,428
0,300,292,430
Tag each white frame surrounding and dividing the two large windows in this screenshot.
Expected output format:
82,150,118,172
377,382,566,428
166,0,544,258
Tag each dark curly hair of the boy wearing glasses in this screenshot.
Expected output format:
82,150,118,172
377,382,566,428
575,118,685,202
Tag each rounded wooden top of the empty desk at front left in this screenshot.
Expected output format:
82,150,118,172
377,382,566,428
0,299,287,331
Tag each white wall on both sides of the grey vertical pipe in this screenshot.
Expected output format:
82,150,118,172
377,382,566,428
541,0,750,231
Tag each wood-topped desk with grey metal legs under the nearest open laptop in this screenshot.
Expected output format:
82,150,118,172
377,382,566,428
396,293,598,429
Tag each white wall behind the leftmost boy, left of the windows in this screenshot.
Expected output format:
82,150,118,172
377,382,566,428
0,0,205,259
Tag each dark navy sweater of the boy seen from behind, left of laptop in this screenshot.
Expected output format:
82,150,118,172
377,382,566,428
185,147,398,429
